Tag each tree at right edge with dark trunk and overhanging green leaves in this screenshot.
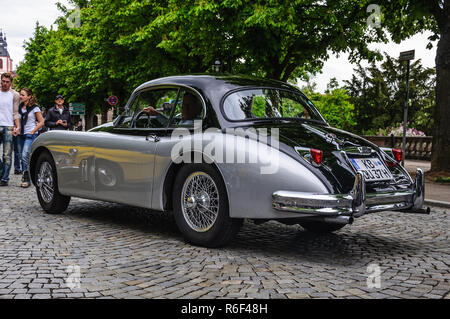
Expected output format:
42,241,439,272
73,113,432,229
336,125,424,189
377,0,450,172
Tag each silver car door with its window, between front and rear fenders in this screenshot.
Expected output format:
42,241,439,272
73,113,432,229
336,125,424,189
95,88,178,208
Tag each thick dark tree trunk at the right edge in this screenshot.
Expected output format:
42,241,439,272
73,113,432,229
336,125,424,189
431,14,450,173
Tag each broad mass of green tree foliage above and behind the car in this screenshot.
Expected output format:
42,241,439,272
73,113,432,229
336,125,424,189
18,0,383,129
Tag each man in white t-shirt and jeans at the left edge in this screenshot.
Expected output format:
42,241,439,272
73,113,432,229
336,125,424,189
0,73,20,186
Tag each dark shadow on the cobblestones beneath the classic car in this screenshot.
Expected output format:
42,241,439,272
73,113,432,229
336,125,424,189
53,202,423,266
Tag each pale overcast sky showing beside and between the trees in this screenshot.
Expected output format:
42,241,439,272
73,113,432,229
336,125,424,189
0,0,437,93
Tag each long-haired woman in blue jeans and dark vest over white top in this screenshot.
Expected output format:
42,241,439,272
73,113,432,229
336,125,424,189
17,88,44,188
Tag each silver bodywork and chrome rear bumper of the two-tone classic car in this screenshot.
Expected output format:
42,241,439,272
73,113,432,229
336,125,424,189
30,77,424,223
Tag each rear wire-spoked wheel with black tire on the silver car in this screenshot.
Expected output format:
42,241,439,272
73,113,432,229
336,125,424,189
173,164,242,247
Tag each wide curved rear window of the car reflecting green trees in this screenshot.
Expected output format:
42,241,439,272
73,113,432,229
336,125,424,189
223,89,325,122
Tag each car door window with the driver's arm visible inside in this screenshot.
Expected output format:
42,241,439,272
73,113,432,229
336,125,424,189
122,88,178,128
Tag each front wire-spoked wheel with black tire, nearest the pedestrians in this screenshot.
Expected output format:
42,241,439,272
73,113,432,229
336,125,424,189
34,152,70,214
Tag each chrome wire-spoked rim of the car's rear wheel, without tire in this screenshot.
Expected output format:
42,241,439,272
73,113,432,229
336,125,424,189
181,172,219,232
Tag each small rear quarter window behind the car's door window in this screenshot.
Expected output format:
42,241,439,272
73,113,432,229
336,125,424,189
169,89,204,128
